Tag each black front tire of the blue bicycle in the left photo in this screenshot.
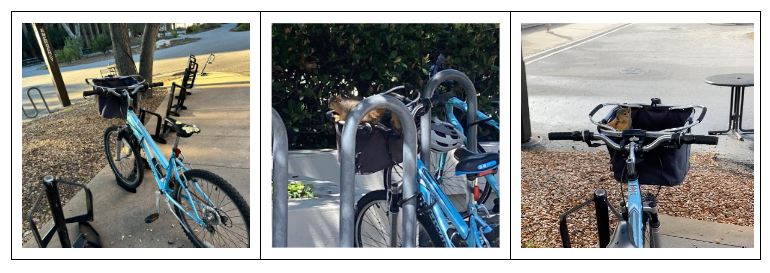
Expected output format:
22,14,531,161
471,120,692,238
104,125,144,193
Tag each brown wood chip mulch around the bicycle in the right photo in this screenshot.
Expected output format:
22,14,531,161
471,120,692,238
521,150,754,247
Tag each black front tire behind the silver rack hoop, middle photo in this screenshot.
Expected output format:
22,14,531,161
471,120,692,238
354,190,447,247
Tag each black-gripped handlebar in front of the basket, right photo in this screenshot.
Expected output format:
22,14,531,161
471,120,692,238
548,130,719,152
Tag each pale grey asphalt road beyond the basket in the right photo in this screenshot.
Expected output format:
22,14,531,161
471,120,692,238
526,24,754,160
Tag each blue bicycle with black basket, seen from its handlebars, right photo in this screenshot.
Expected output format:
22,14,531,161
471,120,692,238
548,98,719,248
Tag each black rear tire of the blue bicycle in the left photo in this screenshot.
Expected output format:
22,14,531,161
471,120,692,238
174,169,250,248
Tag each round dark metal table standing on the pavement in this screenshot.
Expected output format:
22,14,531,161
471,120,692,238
706,73,754,140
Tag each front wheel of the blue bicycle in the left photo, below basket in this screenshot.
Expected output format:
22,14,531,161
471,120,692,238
104,125,144,192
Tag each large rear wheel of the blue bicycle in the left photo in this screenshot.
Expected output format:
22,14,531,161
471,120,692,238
174,170,249,248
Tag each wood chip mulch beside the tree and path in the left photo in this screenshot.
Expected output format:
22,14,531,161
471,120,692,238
22,88,168,239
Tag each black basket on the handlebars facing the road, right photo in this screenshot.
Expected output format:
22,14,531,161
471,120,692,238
605,105,695,187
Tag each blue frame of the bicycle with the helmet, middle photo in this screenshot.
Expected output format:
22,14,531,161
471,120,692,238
417,159,491,247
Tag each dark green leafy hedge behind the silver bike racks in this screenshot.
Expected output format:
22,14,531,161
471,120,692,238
272,24,500,149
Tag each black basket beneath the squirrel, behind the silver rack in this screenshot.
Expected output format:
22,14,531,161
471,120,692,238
334,115,404,174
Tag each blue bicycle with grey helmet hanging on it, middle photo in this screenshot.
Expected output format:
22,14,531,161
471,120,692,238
354,87,499,247
